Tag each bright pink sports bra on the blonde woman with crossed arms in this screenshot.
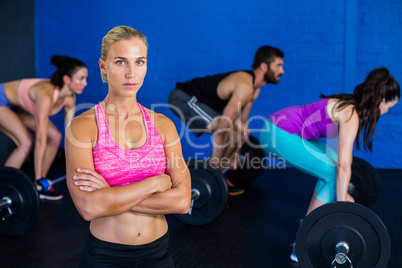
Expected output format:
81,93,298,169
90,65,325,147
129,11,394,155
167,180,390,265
93,103,166,186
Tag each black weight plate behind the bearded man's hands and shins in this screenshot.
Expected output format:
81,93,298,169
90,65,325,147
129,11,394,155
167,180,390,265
225,135,266,185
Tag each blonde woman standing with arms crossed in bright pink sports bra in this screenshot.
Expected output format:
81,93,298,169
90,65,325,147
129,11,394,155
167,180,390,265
65,26,191,268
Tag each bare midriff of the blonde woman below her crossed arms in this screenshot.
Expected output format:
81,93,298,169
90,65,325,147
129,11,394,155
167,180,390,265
89,212,168,245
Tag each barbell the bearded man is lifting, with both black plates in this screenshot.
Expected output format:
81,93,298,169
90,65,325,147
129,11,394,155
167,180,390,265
174,136,266,226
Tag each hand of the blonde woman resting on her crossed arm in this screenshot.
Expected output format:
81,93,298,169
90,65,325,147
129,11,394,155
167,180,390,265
73,168,110,192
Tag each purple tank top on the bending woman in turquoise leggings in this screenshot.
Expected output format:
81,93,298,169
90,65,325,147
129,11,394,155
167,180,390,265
269,99,338,140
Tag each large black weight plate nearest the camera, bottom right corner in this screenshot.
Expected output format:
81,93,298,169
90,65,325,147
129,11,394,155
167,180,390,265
296,202,391,268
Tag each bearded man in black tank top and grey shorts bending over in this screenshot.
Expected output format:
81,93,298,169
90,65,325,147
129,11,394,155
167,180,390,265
169,46,284,195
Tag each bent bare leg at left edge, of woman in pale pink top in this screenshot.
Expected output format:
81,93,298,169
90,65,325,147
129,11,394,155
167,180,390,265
0,106,33,169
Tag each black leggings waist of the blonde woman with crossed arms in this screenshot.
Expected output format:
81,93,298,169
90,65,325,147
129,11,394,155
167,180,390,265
80,233,174,268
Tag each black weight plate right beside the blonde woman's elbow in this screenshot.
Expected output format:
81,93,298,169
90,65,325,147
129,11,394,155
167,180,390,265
174,159,228,226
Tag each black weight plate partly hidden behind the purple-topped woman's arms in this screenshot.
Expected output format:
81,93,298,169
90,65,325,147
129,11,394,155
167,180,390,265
349,157,381,209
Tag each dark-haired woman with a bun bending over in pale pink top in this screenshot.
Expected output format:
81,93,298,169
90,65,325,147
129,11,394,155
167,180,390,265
0,55,88,200
